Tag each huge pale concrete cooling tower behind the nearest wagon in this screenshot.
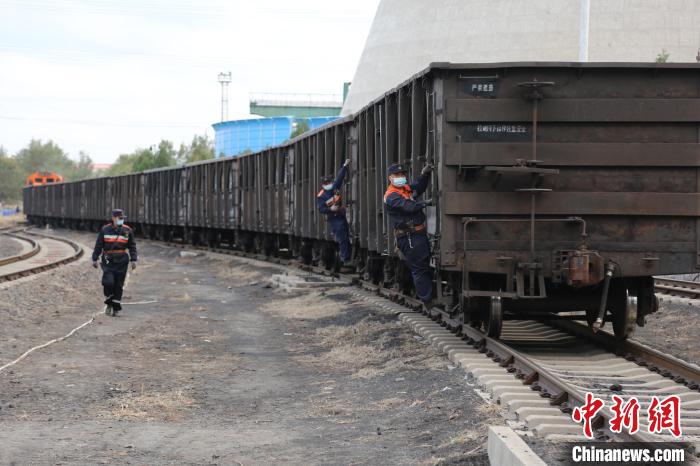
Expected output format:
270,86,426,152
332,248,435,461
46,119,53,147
342,0,700,115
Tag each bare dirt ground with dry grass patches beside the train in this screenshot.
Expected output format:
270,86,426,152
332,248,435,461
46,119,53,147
0,232,504,465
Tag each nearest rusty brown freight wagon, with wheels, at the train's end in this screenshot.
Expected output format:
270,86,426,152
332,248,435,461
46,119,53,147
342,63,700,338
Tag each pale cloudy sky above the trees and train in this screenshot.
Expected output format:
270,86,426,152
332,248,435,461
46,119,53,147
0,0,379,163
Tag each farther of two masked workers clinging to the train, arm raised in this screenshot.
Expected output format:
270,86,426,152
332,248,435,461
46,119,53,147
316,159,355,272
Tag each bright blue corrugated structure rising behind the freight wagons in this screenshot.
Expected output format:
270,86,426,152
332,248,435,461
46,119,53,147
212,116,338,157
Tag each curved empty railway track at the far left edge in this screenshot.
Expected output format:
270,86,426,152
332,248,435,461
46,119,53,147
0,229,83,282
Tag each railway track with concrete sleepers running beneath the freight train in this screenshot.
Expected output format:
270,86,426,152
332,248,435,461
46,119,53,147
157,238,700,451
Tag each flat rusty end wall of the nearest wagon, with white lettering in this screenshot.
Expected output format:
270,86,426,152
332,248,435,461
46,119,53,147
433,63,700,297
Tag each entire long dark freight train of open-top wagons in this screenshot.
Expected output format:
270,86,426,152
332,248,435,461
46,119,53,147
24,63,700,339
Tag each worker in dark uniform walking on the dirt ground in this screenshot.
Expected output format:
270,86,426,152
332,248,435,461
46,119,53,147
92,209,138,317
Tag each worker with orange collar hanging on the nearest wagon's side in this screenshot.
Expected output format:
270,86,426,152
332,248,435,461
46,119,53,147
384,163,433,309
